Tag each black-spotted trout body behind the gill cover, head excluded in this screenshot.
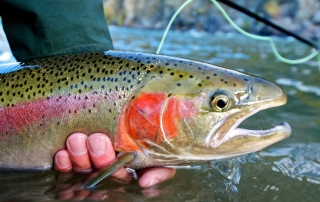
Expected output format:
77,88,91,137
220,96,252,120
0,52,151,169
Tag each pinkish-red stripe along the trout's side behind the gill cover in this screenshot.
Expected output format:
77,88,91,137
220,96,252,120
0,93,118,135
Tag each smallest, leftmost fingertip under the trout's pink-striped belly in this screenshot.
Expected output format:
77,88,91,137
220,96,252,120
54,150,72,172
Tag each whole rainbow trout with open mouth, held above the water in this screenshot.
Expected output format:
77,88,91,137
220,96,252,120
0,51,291,185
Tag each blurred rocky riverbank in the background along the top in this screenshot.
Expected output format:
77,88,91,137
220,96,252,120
104,0,320,40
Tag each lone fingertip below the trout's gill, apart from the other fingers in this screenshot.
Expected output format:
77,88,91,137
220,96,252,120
139,168,176,188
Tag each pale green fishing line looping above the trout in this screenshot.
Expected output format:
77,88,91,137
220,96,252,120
156,0,320,71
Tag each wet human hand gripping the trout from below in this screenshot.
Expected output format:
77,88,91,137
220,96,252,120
54,133,176,188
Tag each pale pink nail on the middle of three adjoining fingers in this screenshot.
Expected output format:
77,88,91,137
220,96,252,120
67,135,87,156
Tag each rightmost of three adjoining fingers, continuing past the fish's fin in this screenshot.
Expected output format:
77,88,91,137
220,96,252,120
87,133,132,181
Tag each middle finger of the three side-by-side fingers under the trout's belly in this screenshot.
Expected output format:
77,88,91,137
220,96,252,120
67,133,92,173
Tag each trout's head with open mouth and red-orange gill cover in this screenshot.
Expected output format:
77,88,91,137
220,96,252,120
116,54,291,165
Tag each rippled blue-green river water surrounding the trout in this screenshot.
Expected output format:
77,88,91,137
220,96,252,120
0,26,320,202
